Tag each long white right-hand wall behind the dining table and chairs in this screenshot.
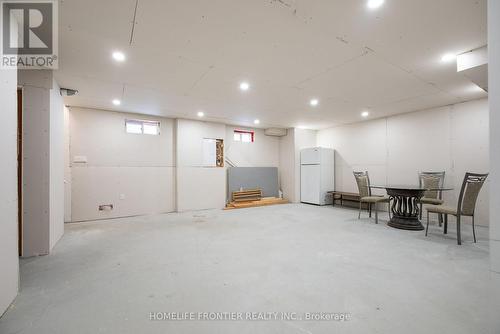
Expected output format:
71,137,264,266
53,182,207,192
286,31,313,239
318,99,490,225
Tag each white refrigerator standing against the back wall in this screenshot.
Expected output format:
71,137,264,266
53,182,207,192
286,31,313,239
300,147,335,205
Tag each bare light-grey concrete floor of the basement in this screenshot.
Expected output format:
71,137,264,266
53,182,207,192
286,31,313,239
0,205,490,334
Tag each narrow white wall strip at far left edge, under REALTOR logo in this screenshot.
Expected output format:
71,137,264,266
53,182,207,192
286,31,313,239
0,70,19,316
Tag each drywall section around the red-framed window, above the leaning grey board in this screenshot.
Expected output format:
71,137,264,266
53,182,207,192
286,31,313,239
224,125,280,167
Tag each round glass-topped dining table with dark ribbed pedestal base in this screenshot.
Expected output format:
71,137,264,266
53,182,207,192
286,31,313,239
370,185,453,231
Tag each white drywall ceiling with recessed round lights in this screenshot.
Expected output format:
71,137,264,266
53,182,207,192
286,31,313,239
56,0,487,129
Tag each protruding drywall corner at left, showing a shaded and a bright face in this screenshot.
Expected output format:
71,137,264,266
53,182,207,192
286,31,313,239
18,70,64,257
